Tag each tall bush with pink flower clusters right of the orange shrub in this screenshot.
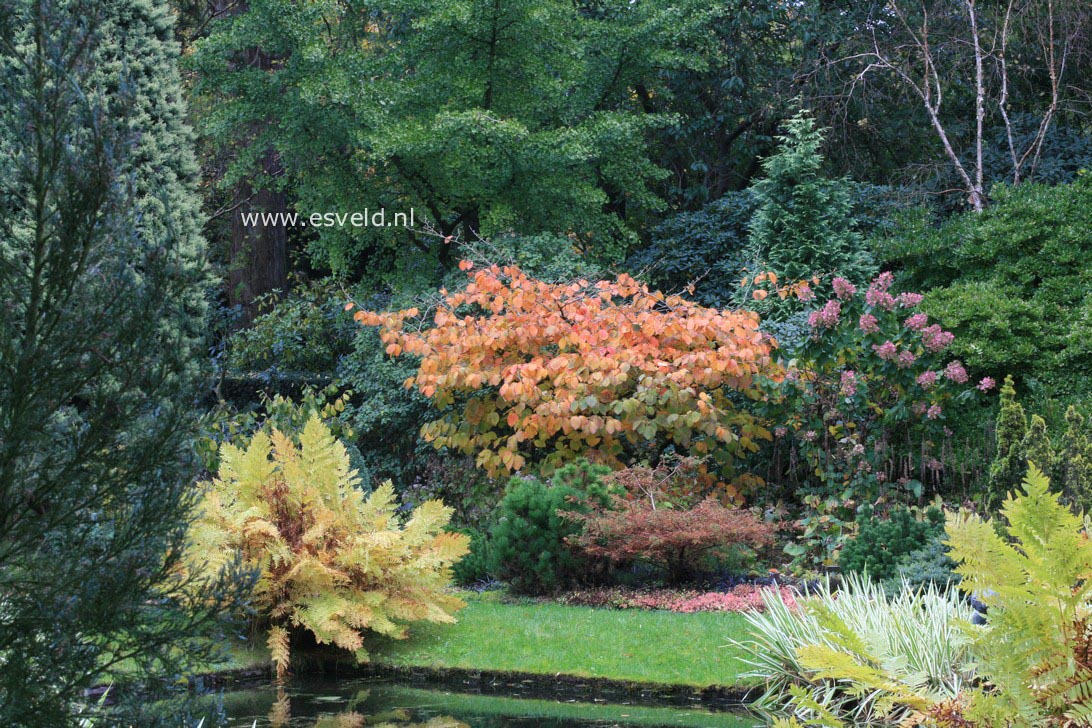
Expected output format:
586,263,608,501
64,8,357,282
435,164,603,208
763,273,993,510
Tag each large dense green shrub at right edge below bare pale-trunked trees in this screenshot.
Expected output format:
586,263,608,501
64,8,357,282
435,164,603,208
876,174,1092,396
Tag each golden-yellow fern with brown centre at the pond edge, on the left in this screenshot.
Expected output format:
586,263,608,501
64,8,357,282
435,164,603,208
189,417,468,675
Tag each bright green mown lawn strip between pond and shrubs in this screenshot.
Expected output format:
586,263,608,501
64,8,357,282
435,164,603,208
367,595,746,688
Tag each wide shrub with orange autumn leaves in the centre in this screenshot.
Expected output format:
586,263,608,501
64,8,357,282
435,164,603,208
355,261,776,488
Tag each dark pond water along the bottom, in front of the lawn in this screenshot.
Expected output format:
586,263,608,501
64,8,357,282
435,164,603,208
215,678,763,728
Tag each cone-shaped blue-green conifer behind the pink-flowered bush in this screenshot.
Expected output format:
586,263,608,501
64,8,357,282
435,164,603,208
743,111,875,318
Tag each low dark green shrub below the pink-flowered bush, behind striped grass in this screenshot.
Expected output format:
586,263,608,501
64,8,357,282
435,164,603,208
839,506,945,582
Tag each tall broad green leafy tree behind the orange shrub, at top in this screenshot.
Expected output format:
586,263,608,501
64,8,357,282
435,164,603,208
193,0,666,286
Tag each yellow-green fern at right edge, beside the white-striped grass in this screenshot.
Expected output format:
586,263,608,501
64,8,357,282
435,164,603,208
947,465,1092,726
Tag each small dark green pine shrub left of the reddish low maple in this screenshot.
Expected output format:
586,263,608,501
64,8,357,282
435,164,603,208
489,461,609,594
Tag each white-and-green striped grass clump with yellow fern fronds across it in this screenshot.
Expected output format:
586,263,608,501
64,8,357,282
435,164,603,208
740,575,973,726
